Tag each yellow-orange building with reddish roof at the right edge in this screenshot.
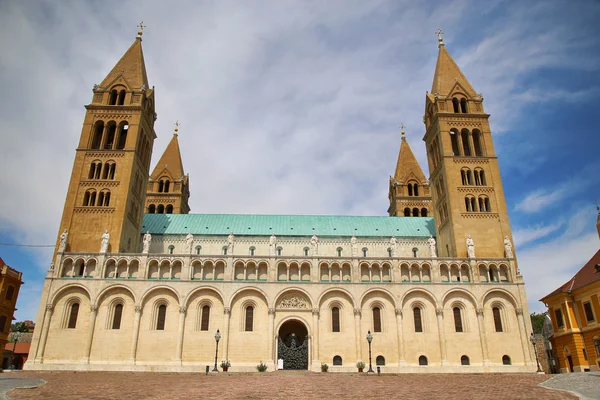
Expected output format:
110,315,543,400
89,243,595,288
540,216,600,372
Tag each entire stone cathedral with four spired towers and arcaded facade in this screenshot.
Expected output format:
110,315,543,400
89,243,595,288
25,31,536,373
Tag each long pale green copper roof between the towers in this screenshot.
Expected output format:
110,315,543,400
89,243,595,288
142,214,435,238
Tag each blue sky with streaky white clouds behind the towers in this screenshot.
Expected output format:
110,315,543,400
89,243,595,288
0,0,600,320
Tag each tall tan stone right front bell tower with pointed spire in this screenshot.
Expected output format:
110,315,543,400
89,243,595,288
423,31,512,258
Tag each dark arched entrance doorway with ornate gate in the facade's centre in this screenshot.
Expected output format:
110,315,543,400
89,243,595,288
277,319,308,369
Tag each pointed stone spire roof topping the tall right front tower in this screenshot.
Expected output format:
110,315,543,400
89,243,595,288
431,36,477,97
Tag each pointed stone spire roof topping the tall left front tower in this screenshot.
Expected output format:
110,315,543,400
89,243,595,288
100,29,149,89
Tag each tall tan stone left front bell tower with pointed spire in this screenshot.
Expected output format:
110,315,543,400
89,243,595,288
57,24,156,253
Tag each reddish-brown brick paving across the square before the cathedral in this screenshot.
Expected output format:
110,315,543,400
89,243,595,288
10,372,577,400
